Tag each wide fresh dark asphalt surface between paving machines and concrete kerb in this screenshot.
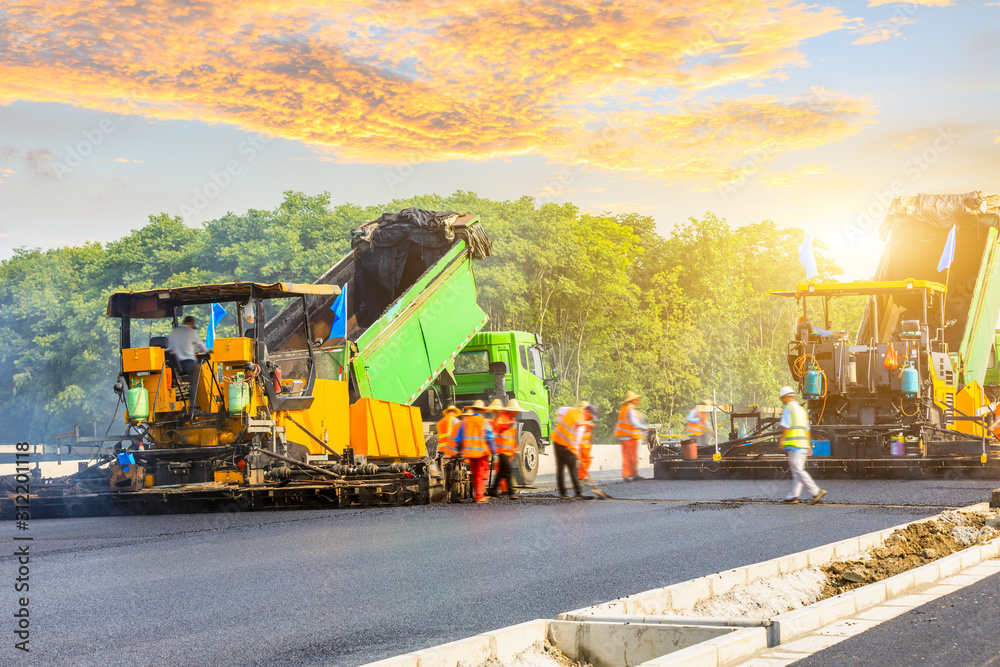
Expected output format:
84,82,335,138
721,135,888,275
0,480,995,665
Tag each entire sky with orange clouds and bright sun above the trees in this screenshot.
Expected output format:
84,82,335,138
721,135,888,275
0,0,1000,279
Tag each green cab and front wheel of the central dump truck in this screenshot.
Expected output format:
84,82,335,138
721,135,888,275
454,331,557,485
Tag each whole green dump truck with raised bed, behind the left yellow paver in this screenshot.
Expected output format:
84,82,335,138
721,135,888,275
265,209,556,484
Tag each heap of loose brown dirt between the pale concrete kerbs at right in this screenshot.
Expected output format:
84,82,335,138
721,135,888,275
822,511,997,598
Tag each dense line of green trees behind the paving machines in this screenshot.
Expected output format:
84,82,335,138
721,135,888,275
0,191,857,442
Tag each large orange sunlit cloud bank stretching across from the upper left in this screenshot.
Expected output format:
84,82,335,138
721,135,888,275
0,0,864,183
